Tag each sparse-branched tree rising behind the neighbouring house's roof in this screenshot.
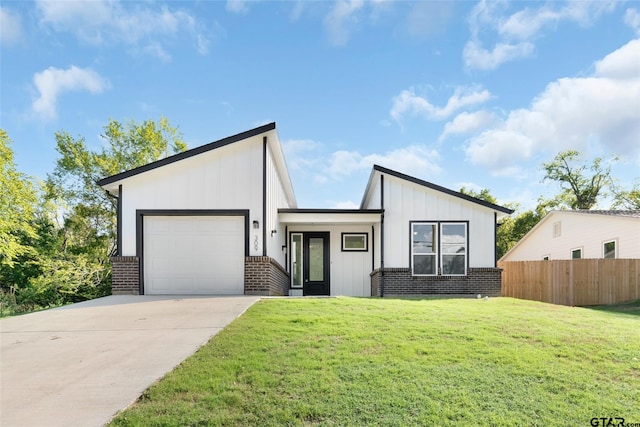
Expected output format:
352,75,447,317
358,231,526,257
542,150,618,209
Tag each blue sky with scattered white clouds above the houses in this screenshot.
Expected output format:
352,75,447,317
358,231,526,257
0,0,640,208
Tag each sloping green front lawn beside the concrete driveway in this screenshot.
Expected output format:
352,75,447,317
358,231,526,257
112,298,640,426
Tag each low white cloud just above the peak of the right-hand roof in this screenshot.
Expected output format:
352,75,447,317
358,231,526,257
328,145,442,177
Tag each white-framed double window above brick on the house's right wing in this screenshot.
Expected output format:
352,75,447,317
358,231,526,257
411,222,467,276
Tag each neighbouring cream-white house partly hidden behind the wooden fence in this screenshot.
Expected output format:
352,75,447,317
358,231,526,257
500,210,640,261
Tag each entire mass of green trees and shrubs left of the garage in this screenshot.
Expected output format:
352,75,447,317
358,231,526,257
0,118,186,315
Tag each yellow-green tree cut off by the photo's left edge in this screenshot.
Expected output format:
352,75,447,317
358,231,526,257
0,129,38,270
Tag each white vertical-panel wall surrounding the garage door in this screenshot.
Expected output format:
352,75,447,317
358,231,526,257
121,136,262,256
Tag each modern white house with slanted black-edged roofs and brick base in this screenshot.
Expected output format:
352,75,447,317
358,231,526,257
99,123,512,296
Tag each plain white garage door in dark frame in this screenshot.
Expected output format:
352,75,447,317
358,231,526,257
143,216,244,295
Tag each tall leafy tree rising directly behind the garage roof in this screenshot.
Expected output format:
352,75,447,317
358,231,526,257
47,117,186,260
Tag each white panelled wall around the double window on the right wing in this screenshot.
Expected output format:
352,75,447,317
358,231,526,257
380,175,495,268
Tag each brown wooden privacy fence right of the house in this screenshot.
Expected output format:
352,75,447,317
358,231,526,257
498,259,640,306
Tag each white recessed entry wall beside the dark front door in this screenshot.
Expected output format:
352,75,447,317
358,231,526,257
288,224,373,297
